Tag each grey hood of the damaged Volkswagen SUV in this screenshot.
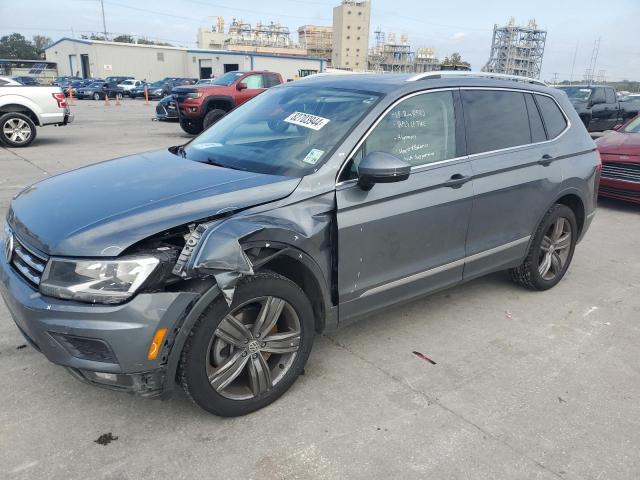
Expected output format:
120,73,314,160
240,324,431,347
7,150,300,257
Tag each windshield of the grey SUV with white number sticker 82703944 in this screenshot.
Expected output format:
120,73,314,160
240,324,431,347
184,86,379,177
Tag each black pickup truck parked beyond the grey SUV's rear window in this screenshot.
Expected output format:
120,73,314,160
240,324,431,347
558,85,640,132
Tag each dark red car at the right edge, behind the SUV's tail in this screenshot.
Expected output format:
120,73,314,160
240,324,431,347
598,115,640,203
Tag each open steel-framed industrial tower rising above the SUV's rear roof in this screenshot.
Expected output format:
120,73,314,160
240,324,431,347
482,17,547,78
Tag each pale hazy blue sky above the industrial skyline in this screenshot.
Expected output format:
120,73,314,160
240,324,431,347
0,0,640,80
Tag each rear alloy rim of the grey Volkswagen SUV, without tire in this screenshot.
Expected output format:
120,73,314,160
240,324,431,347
538,217,573,280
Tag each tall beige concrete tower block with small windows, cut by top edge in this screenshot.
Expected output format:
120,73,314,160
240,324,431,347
331,0,371,71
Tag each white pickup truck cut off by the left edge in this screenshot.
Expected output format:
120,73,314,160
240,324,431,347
0,77,73,147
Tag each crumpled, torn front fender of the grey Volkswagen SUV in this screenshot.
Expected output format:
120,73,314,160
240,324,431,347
188,195,334,305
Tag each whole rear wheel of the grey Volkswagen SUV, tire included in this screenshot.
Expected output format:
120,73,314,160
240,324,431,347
509,203,578,290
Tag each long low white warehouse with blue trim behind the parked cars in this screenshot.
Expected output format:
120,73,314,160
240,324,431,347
45,38,326,81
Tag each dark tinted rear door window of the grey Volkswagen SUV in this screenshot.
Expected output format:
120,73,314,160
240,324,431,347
462,90,531,155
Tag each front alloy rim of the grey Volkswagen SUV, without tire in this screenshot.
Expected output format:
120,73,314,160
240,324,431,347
206,296,302,400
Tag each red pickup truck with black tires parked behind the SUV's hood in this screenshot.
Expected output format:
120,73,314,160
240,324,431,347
172,71,282,135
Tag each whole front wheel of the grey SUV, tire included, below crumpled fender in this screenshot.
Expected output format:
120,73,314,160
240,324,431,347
178,271,314,417
